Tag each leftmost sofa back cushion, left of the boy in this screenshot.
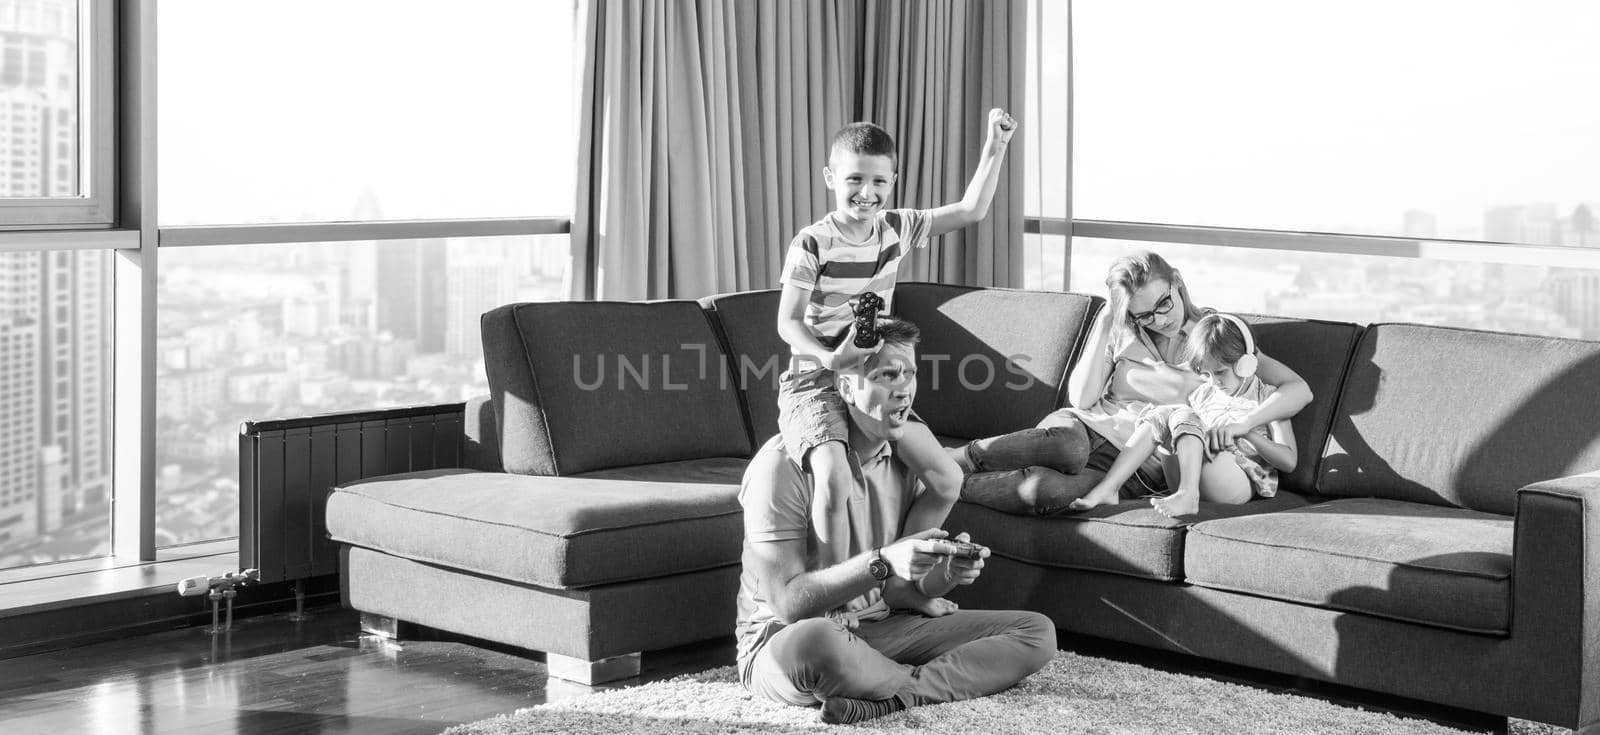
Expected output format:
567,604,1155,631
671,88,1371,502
482,301,754,476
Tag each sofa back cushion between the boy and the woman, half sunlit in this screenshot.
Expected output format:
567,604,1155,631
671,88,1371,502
891,283,1102,439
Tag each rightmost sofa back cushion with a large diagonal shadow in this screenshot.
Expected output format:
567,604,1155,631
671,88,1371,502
1317,323,1600,514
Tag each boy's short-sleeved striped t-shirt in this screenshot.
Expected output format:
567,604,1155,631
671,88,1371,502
779,204,930,344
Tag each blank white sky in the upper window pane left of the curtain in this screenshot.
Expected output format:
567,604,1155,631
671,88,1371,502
157,0,576,224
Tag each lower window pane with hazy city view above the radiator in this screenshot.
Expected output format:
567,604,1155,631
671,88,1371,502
155,235,566,546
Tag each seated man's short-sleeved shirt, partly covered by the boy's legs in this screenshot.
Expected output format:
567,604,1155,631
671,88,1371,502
736,437,922,668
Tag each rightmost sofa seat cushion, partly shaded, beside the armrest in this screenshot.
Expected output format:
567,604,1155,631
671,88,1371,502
1184,498,1512,633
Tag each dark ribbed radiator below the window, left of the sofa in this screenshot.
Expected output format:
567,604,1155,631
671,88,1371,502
238,404,466,583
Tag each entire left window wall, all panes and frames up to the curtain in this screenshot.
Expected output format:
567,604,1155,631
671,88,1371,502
0,0,578,578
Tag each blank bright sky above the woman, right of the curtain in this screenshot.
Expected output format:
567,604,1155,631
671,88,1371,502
1072,0,1600,231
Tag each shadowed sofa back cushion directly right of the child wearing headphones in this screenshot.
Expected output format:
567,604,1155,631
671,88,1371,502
1242,314,1362,493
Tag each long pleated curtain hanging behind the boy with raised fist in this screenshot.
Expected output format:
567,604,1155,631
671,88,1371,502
568,0,1026,299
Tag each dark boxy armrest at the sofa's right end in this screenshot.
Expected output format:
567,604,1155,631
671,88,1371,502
1512,472,1600,732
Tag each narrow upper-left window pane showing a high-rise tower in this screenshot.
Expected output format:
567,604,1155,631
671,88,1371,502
0,0,115,229
